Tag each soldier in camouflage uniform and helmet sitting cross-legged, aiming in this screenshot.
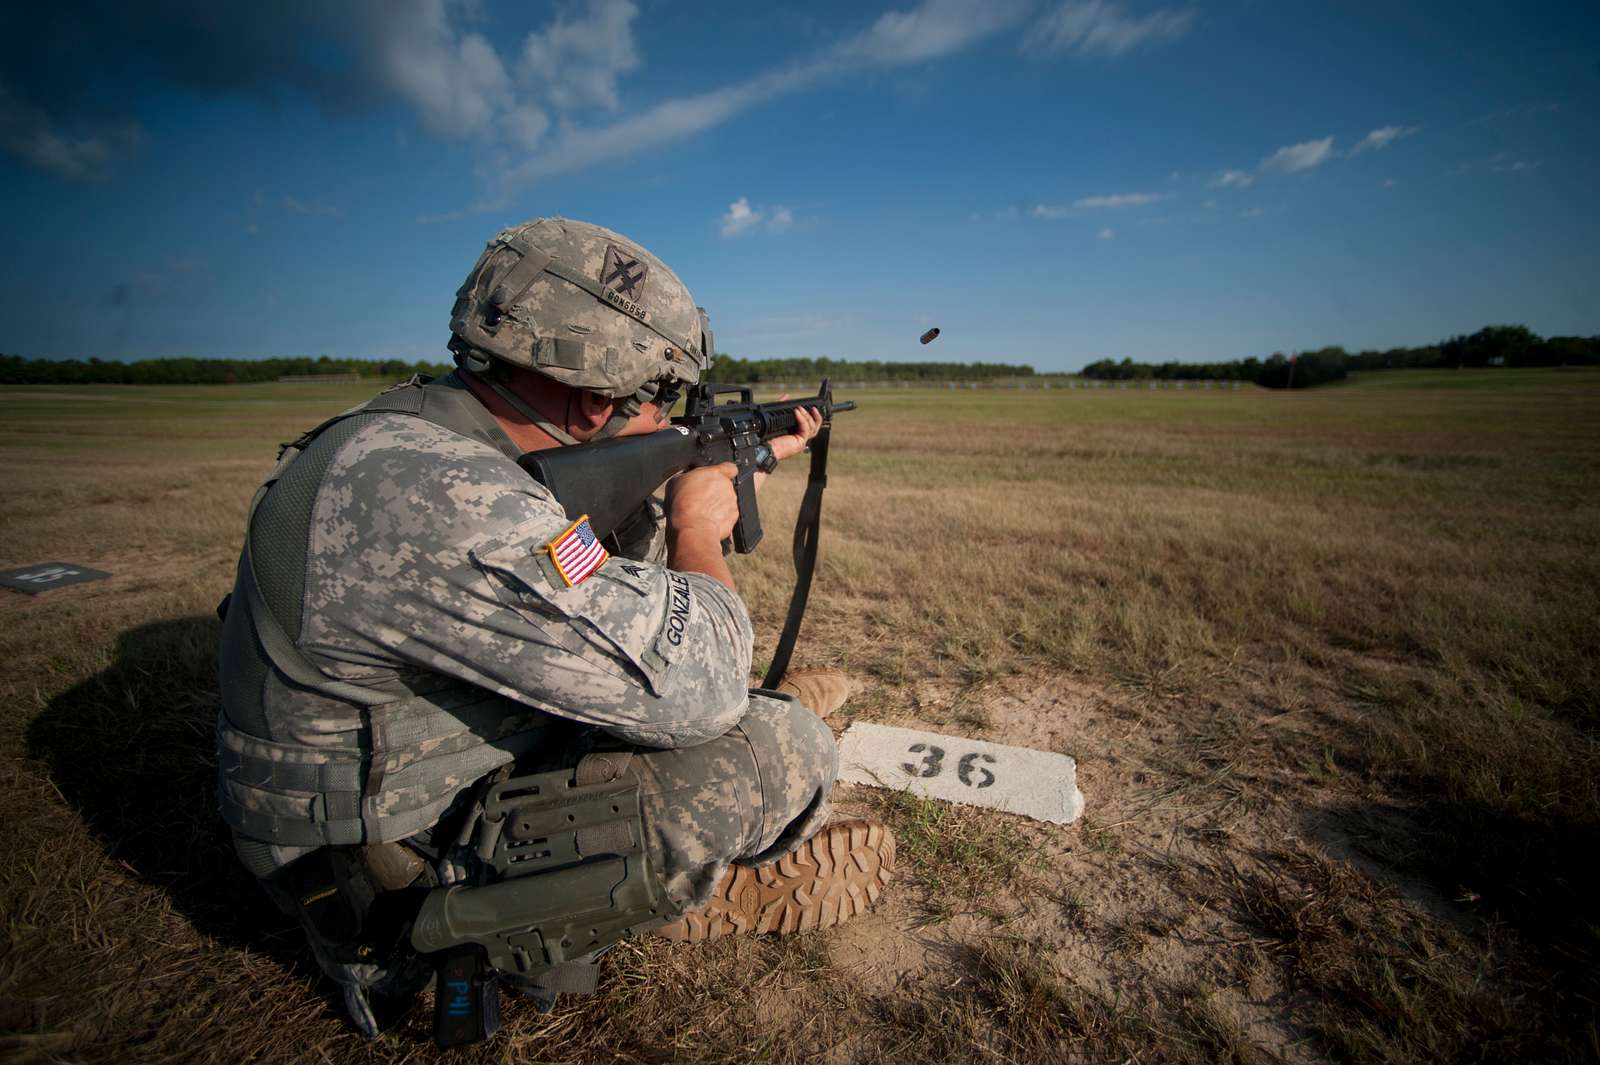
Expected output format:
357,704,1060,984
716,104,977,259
218,219,894,1041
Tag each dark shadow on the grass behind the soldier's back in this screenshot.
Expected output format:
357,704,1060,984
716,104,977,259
27,616,317,975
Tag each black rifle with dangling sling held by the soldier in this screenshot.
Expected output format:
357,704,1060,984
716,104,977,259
517,377,856,688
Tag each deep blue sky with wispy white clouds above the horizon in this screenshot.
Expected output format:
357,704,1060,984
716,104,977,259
0,0,1600,369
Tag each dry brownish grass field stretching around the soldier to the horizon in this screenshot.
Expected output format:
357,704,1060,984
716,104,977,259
0,371,1600,1063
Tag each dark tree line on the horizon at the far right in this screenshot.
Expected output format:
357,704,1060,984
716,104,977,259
1082,325,1600,389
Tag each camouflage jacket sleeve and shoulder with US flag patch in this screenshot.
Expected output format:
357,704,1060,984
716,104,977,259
299,406,750,747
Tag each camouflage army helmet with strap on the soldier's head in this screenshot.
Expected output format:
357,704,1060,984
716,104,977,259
450,217,712,413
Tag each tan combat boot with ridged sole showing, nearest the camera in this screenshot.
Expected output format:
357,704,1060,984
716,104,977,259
656,819,894,943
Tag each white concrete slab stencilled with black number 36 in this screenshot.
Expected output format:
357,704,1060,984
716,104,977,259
838,721,1083,825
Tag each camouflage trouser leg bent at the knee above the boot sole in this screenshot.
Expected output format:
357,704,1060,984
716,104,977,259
579,692,838,908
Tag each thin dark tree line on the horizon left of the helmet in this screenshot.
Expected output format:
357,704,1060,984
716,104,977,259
0,355,451,384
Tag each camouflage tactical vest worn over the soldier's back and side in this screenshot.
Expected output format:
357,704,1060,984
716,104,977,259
218,374,558,876
